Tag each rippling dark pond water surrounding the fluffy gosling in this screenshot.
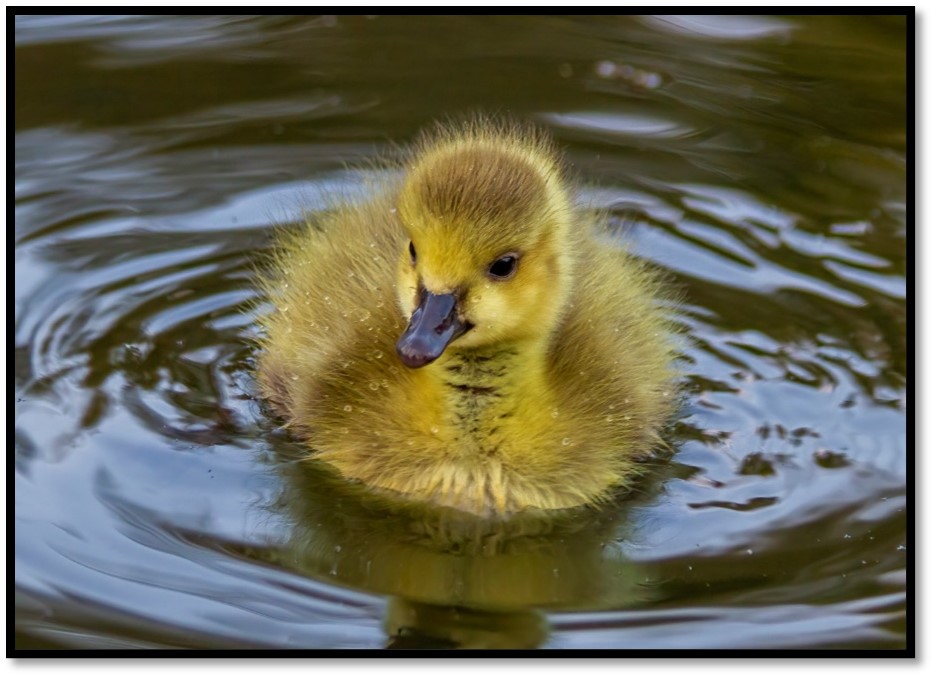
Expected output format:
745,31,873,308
11,16,911,649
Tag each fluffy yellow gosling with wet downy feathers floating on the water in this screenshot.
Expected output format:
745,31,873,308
259,122,674,516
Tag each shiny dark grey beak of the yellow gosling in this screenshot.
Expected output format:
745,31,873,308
396,290,470,369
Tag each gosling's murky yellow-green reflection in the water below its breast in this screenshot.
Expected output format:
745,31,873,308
251,444,672,648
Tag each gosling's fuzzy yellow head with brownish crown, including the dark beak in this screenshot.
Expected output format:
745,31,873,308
396,132,572,368
